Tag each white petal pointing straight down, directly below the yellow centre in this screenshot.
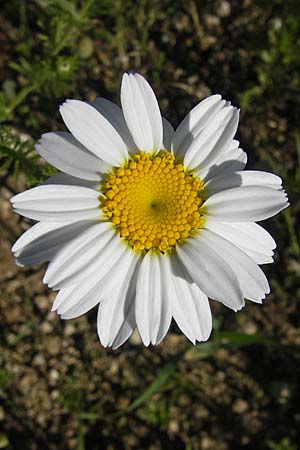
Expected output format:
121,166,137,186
135,251,174,346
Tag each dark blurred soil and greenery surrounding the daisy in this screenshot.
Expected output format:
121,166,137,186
0,0,300,450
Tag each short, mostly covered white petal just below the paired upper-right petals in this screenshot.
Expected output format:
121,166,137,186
200,140,247,181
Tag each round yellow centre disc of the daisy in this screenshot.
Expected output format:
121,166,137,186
101,152,204,252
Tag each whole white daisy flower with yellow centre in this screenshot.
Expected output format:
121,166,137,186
11,74,288,348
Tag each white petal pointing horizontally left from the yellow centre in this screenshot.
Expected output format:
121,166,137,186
11,185,101,222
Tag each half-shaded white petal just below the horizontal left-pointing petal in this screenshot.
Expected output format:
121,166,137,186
12,221,98,266
